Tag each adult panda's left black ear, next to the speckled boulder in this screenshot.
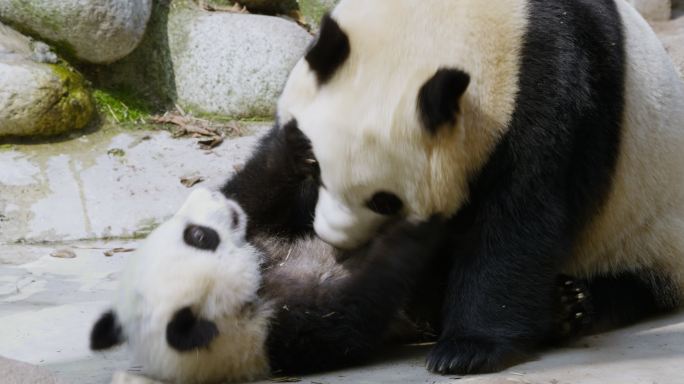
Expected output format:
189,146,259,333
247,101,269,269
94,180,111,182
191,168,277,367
305,15,351,85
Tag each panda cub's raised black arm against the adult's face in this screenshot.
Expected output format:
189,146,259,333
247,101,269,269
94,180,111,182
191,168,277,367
221,122,320,238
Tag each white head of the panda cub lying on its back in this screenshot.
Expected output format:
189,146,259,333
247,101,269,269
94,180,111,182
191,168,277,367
91,189,271,382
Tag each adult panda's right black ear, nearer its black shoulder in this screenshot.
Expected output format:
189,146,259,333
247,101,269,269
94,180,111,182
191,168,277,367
418,68,470,134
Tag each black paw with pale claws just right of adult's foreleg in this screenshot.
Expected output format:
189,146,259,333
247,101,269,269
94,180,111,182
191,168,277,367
552,275,593,341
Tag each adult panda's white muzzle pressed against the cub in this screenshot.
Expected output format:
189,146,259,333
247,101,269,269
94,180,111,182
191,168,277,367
314,188,386,250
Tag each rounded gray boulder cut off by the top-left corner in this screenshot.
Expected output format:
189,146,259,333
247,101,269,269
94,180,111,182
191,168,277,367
0,0,152,63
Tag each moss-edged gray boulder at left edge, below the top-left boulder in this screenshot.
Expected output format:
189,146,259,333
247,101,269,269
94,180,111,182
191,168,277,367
0,24,95,138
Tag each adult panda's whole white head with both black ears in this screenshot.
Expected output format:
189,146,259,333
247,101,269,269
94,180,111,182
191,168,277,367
278,0,476,249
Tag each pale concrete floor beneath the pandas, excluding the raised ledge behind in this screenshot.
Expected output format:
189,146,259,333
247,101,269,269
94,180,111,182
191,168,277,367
0,241,684,384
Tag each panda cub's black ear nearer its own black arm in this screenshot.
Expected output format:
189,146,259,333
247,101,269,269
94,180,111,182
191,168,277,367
166,307,219,352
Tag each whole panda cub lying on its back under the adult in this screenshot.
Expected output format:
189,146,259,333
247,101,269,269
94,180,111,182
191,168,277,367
91,127,448,383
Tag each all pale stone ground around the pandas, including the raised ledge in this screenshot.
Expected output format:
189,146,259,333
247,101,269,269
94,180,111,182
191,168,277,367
0,124,684,384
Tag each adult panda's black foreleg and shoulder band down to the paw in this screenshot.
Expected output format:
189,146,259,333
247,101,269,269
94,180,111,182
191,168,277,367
428,0,627,373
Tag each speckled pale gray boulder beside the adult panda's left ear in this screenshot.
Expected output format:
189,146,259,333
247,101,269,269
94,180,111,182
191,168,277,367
169,10,312,117
